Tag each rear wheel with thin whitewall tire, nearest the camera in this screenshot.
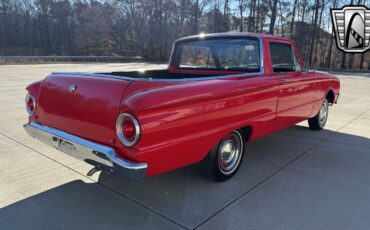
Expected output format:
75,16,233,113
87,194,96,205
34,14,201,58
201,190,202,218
203,130,245,181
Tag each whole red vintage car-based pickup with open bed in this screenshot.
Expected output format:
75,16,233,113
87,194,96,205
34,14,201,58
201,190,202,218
24,33,340,181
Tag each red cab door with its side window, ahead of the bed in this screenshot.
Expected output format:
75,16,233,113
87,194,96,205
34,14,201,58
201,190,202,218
269,41,314,129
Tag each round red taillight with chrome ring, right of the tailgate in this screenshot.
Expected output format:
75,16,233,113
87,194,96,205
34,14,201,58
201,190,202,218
116,113,140,146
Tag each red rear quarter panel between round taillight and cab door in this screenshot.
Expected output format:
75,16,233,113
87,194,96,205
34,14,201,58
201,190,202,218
117,76,278,175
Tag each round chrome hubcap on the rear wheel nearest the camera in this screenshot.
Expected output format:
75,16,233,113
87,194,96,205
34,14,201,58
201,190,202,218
218,132,243,174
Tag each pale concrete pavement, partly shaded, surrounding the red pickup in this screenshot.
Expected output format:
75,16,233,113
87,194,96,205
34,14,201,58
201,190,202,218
0,64,370,229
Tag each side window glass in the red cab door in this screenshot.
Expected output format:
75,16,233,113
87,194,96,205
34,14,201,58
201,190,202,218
270,42,295,73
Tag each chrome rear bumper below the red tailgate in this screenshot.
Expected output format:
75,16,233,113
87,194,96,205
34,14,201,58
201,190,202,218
23,122,148,181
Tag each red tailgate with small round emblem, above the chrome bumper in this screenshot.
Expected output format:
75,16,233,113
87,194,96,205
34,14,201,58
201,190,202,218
35,74,130,144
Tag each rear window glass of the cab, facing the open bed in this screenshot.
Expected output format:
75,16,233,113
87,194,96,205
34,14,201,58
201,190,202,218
176,38,260,72
